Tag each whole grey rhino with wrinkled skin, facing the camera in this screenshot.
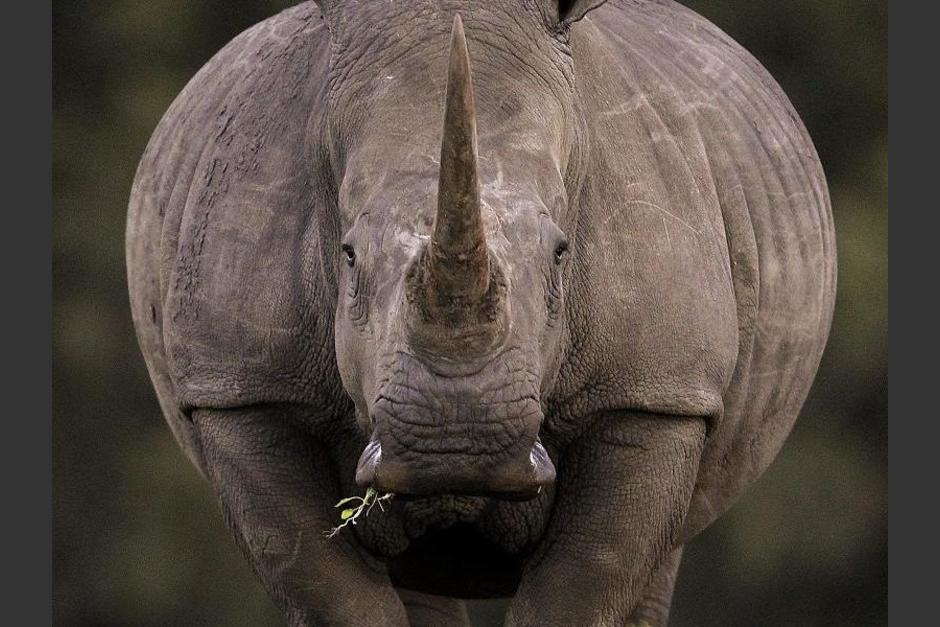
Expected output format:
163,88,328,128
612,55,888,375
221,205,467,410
127,0,835,626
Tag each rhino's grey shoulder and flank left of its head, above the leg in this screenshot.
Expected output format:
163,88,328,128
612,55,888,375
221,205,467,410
128,3,338,420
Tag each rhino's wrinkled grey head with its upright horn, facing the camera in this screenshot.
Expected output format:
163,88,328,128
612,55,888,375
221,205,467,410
323,2,600,498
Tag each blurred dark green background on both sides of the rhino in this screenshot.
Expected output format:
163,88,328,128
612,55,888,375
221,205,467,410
53,0,888,627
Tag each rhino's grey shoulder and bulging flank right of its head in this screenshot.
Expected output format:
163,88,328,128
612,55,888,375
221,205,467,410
556,0,835,535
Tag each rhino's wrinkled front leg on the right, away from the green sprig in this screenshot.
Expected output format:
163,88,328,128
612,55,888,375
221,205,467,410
506,412,705,627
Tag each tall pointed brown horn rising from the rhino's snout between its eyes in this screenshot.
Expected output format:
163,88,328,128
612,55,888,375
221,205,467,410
430,15,490,302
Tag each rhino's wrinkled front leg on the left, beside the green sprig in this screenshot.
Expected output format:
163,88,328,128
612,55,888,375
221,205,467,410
193,409,408,627
